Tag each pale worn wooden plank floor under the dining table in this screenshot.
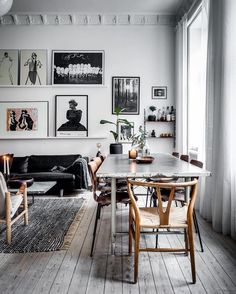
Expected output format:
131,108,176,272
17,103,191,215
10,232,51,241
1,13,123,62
0,193,236,294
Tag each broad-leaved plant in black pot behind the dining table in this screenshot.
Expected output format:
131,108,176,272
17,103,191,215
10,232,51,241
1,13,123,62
100,107,133,154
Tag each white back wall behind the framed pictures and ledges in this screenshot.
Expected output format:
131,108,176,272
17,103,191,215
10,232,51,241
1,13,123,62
0,25,175,156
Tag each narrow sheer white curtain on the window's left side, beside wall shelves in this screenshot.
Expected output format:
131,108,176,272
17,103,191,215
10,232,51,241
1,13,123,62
175,15,187,153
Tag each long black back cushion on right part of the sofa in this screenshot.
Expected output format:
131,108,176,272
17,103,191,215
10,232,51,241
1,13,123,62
28,154,81,173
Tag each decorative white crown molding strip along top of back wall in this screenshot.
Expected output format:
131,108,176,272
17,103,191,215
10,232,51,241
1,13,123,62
0,13,176,26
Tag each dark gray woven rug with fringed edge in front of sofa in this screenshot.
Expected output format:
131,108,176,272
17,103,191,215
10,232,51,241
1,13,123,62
0,198,85,253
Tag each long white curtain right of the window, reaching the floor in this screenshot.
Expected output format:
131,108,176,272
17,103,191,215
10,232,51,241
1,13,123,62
200,0,236,239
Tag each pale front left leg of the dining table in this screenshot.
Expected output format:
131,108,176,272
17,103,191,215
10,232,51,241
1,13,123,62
111,178,116,255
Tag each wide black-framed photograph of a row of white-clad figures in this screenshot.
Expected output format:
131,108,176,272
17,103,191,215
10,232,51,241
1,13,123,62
52,51,104,85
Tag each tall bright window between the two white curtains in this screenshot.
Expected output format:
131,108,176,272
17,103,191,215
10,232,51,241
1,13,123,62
187,7,207,162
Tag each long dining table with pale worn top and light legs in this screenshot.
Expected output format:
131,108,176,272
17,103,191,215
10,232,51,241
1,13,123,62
97,153,211,254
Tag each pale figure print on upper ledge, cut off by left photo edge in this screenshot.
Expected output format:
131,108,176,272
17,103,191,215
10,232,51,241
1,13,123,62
0,49,19,86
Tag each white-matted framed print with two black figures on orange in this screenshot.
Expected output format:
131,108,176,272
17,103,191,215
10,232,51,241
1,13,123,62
0,101,48,138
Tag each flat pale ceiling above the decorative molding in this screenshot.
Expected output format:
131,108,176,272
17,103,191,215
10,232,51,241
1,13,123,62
11,0,189,15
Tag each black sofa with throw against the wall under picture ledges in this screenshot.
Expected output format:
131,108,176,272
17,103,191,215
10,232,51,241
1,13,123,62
10,154,88,196
